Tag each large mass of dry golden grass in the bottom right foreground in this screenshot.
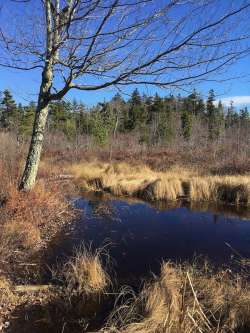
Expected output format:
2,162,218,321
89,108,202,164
103,263,250,333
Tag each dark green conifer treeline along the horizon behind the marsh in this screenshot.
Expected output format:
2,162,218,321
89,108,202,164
0,89,250,145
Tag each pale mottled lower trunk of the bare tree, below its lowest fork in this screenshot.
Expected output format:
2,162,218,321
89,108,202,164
19,103,49,191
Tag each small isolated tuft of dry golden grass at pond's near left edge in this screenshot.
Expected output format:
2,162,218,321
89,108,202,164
62,246,110,297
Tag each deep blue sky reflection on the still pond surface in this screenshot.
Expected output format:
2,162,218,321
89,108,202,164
71,198,250,275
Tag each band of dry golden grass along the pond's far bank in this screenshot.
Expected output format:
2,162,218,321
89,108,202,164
69,161,250,206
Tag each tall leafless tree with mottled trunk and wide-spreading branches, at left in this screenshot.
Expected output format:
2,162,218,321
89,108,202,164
0,0,250,190
